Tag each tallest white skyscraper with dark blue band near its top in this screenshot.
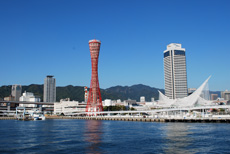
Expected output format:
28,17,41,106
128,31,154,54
164,43,188,99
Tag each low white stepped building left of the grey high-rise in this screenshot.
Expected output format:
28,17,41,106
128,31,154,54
19,91,41,107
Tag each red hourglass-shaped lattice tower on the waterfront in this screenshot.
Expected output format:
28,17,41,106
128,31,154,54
86,39,103,112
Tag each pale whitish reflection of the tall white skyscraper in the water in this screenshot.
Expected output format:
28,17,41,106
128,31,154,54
163,123,198,154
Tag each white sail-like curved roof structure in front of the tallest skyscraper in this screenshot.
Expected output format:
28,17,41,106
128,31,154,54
158,76,212,107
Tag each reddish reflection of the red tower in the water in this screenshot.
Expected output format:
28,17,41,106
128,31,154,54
84,120,103,154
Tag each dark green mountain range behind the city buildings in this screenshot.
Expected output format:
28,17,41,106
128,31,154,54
0,84,164,101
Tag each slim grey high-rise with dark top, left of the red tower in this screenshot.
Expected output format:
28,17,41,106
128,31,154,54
43,75,56,102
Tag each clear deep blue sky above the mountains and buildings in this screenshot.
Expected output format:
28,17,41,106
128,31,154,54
0,0,230,90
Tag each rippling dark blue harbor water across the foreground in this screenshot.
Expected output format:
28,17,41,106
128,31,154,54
0,119,230,154
